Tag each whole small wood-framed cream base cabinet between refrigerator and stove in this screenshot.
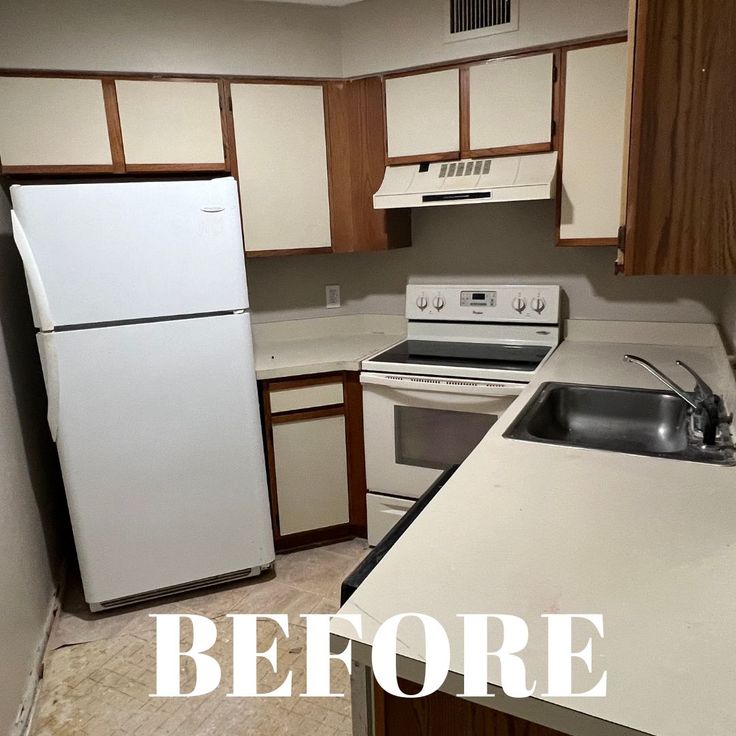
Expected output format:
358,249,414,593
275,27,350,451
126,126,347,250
261,372,366,550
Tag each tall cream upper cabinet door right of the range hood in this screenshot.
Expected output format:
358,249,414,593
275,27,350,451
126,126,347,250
558,41,627,245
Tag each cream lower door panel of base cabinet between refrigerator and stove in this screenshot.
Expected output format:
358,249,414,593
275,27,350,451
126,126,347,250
273,416,350,535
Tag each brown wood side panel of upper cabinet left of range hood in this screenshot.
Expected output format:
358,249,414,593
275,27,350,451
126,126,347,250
325,77,411,253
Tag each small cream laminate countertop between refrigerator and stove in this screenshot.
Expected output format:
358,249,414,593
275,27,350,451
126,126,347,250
253,314,406,381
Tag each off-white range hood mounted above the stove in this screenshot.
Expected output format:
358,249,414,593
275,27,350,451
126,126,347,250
373,151,557,210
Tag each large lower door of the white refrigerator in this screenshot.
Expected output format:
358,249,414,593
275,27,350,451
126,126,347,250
39,313,274,609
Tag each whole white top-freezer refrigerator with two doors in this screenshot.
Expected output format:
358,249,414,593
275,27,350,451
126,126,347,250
10,178,275,610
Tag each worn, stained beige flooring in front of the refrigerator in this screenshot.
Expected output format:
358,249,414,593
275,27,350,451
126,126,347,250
30,540,367,736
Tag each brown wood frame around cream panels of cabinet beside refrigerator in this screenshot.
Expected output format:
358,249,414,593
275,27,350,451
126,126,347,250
260,371,367,551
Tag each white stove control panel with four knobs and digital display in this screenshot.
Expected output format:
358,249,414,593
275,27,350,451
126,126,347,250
406,284,560,325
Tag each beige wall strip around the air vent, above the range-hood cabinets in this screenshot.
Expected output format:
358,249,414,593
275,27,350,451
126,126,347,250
340,0,628,76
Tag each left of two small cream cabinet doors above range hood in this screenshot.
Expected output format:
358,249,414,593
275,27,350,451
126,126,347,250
386,69,460,158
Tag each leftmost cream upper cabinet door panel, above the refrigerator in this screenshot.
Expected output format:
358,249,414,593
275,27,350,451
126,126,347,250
0,77,112,166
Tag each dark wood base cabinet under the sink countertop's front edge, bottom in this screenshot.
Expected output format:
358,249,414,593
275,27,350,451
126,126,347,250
373,680,565,736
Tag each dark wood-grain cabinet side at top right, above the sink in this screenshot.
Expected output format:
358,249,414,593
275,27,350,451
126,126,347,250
625,0,736,275
